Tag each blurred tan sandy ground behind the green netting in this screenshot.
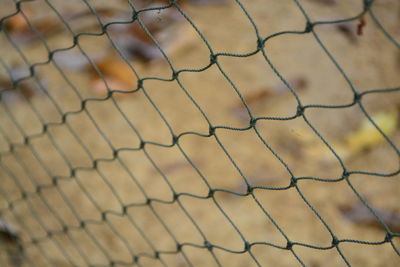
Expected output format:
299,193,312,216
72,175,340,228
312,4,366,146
0,0,400,267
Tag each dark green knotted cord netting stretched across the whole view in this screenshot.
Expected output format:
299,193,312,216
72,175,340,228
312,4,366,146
0,0,400,266
